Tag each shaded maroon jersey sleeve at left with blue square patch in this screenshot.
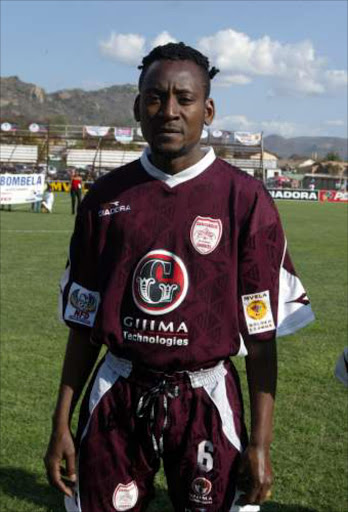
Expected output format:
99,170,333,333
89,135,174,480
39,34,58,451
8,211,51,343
59,208,100,329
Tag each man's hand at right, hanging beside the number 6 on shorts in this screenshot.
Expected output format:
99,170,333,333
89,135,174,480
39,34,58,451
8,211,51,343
237,445,273,505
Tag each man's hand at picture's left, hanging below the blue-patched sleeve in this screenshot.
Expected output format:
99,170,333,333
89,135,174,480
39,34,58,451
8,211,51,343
44,427,76,497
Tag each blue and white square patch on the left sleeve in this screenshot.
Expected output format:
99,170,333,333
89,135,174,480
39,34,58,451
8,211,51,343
64,283,100,327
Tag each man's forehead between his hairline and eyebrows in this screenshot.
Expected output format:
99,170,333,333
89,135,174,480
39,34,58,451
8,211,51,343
141,60,205,91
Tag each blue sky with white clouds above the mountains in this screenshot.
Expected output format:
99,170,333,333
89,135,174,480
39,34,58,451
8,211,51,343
0,0,348,137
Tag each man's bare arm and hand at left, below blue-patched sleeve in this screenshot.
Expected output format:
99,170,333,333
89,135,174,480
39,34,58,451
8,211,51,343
44,329,100,496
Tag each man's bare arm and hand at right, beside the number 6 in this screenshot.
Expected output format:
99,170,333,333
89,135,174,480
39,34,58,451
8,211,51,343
238,340,277,504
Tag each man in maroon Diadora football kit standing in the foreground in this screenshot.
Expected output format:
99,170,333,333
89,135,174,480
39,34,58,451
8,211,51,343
45,43,313,512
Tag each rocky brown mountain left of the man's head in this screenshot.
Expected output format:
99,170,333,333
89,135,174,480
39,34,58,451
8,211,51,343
0,76,137,126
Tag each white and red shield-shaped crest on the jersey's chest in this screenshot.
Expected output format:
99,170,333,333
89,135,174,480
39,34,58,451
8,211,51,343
190,216,222,254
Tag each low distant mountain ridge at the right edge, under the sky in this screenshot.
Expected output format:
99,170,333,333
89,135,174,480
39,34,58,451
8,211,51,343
264,135,348,160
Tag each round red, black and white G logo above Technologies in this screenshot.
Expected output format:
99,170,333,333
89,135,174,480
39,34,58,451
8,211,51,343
132,249,188,315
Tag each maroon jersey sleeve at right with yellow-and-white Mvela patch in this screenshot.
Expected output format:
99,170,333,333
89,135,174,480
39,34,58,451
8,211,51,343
238,182,314,341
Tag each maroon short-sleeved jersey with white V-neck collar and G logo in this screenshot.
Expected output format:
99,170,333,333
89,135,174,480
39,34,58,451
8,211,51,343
61,149,314,371
